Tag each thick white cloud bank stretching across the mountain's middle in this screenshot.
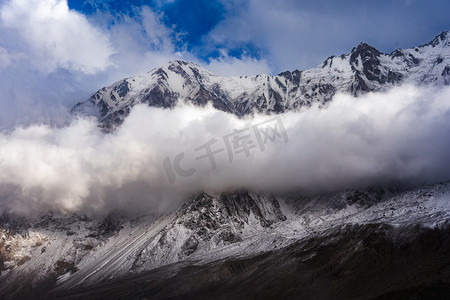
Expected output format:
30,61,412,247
0,86,450,213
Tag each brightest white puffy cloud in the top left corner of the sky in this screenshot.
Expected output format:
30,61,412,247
0,0,114,74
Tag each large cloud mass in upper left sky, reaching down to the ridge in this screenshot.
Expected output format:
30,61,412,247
0,0,185,129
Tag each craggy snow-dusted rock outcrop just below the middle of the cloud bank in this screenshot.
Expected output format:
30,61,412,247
133,192,286,269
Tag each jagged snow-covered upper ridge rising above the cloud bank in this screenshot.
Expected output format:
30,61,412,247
73,31,450,129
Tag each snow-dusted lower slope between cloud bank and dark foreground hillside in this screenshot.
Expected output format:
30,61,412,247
0,183,450,299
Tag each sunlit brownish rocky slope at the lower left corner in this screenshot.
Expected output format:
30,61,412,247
0,213,123,299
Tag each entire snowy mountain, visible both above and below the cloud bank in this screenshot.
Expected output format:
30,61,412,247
0,32,450,299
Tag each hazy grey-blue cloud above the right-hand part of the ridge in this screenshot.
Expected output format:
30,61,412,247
207,0,450,72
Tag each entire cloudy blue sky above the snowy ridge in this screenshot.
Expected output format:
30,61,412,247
0,0,450,128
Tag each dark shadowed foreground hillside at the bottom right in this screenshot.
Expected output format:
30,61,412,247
47,224,450,299
